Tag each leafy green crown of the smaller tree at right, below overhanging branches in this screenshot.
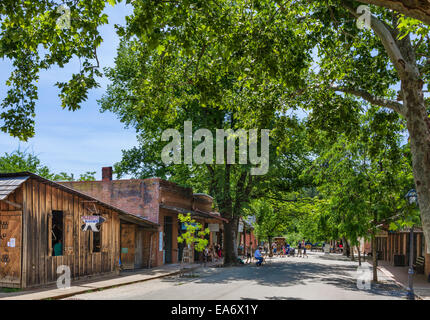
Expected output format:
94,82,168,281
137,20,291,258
307,108,413,245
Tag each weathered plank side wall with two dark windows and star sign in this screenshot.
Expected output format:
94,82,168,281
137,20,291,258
22,179,120,287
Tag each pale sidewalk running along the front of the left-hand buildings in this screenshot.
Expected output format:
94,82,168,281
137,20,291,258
0,263,218,300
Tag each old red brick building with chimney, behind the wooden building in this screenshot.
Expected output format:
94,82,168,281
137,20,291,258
61,167,225,267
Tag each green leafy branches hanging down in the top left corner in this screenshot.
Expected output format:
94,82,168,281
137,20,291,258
0,0,114,141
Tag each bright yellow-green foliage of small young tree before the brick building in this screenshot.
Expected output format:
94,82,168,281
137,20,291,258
178,213,210,252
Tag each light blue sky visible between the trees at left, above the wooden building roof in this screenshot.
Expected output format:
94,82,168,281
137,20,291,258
0,2,137,179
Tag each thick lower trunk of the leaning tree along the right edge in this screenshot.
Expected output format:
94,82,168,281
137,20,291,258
402,79,430,253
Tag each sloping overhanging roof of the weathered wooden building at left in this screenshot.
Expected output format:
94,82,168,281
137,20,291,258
0,172,160,229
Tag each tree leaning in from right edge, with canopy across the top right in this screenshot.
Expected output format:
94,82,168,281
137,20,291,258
112,0,430,255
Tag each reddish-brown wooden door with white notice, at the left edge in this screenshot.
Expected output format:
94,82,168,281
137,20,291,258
0,211,22,287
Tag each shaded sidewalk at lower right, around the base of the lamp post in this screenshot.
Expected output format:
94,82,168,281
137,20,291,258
378,260,430,300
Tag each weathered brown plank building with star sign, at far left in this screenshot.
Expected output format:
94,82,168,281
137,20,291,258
0,172,159,288
